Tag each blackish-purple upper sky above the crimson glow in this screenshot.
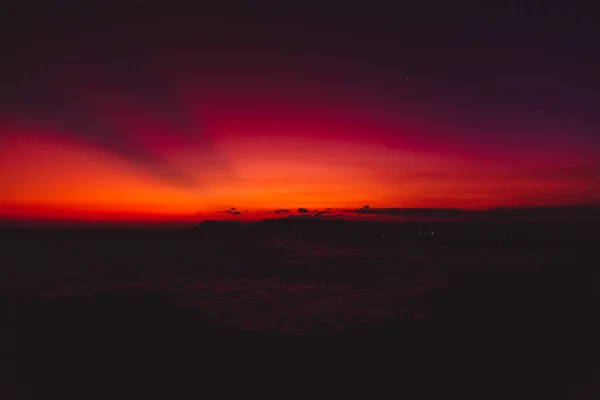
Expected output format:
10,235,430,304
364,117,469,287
0,1,600,131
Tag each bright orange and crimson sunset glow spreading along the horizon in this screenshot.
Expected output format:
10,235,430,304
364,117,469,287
0,86,600,225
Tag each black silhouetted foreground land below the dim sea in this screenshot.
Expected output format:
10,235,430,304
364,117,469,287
0,220,600,399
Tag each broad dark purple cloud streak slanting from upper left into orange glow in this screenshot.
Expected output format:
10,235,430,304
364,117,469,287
0,8,225,186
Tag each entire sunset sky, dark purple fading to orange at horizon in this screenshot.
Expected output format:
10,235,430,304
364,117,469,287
0,1,600,221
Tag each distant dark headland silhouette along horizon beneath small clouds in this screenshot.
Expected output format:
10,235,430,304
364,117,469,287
193,214,600,250
